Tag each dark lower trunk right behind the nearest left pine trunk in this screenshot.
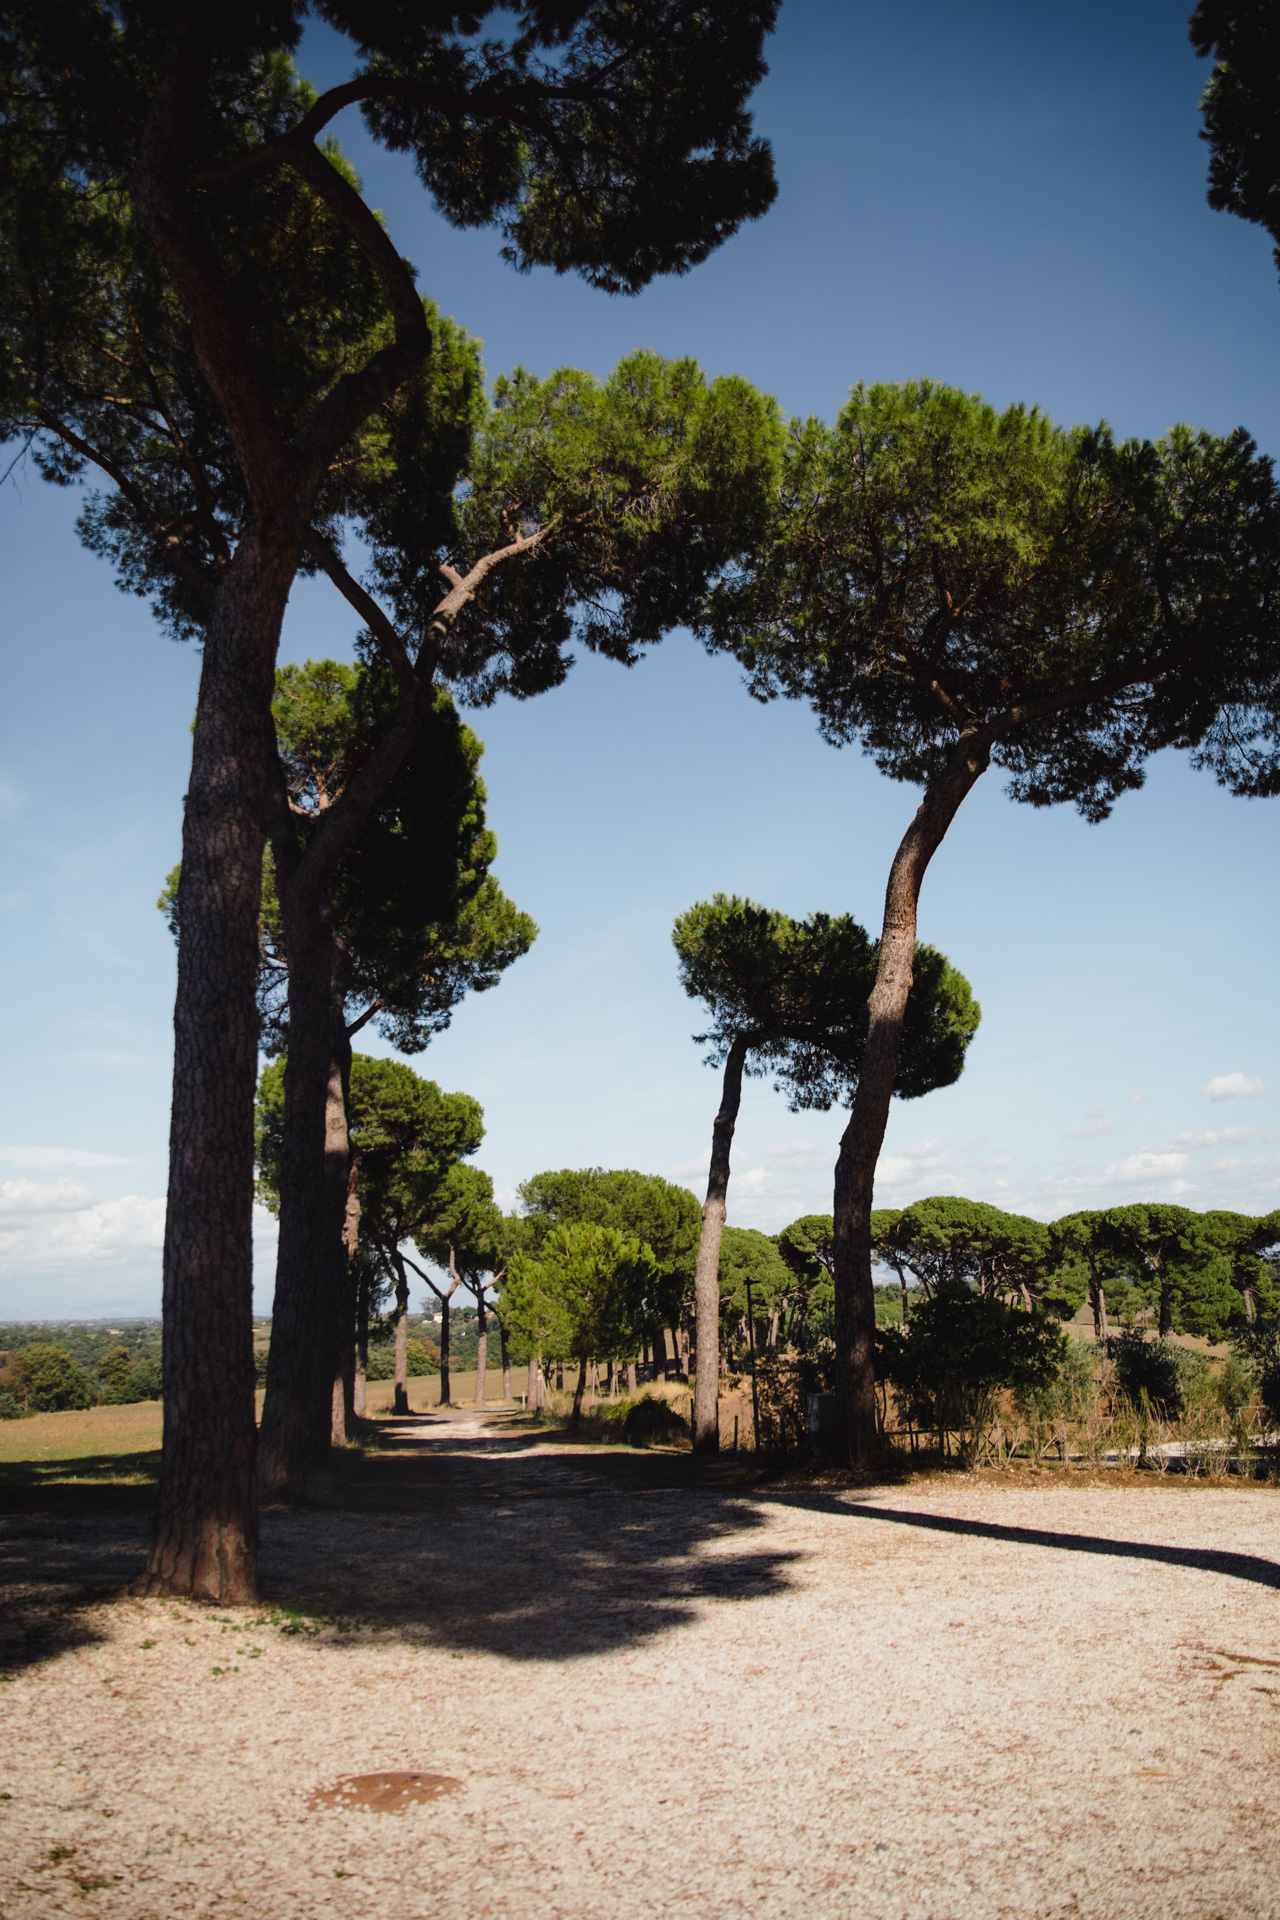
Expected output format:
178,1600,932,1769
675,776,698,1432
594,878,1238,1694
257,917,349,1500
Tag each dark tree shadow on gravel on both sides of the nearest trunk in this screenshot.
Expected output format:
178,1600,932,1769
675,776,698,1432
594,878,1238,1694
0,1423,796,1670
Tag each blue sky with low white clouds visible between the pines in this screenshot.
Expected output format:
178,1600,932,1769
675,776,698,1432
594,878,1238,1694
0,0,1280,1317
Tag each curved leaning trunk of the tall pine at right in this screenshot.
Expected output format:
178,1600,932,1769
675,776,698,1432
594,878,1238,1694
833,735,990,1471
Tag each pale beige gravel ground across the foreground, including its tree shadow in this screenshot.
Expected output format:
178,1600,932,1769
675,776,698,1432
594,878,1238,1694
0,1417,1280,1920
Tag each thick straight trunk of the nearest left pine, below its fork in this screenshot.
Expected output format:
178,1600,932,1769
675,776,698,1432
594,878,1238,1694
144,528,296,1605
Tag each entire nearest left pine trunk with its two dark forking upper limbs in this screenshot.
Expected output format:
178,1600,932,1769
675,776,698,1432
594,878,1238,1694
132,22,432,1605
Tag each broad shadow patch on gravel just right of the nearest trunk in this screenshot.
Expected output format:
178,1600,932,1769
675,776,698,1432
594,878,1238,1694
261,1423,796,1661
